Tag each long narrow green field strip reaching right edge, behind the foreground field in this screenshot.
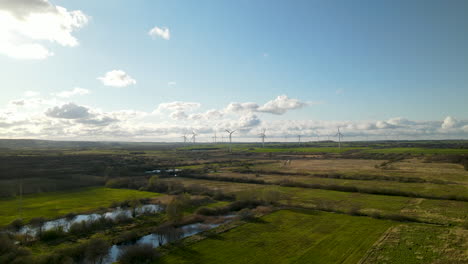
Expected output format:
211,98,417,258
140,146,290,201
164,177,468,224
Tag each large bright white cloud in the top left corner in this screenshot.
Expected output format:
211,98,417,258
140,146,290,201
0,0,89,59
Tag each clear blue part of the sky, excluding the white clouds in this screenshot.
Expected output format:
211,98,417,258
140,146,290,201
0,0,468,139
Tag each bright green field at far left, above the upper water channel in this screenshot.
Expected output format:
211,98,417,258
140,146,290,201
0,187,160,226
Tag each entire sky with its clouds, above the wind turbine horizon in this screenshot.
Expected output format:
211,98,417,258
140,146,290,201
0,0,468,142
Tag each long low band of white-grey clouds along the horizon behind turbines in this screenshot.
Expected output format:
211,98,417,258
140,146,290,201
0,93,468,142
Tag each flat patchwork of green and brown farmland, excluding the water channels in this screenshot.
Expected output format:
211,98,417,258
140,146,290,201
0,141,468,264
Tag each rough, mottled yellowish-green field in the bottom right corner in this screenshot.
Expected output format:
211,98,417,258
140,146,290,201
360,225,468,264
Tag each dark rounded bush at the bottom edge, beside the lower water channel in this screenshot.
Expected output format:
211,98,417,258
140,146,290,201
118,244,159,264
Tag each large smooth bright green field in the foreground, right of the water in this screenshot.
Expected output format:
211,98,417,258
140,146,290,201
162,210,394,264
